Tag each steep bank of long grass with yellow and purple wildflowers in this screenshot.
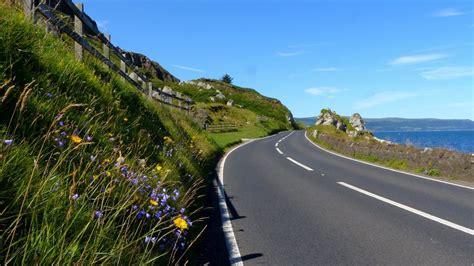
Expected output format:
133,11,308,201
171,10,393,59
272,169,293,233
0,1,218,265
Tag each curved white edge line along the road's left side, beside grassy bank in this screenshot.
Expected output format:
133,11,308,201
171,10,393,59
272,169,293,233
218,130,292,266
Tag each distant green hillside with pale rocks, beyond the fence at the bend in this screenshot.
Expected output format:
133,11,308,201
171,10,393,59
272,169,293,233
154,79,295,148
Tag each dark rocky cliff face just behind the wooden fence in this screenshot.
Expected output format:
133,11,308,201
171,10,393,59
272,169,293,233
119,48,179,82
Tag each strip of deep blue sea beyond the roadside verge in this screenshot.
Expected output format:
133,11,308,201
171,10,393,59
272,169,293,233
374,131,474,154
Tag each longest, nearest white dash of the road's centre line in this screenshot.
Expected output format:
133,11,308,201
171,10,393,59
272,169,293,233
337,182,474,235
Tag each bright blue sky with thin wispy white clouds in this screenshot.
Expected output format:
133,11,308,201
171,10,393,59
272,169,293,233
79,0,474,120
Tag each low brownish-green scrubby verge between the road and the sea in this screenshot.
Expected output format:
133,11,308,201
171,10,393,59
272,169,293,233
307,125,474,182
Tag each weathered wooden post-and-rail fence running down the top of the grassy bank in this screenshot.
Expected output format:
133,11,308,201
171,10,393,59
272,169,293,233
23,0,193,111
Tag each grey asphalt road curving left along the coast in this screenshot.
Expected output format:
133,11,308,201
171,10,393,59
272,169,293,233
224,131,474,265
